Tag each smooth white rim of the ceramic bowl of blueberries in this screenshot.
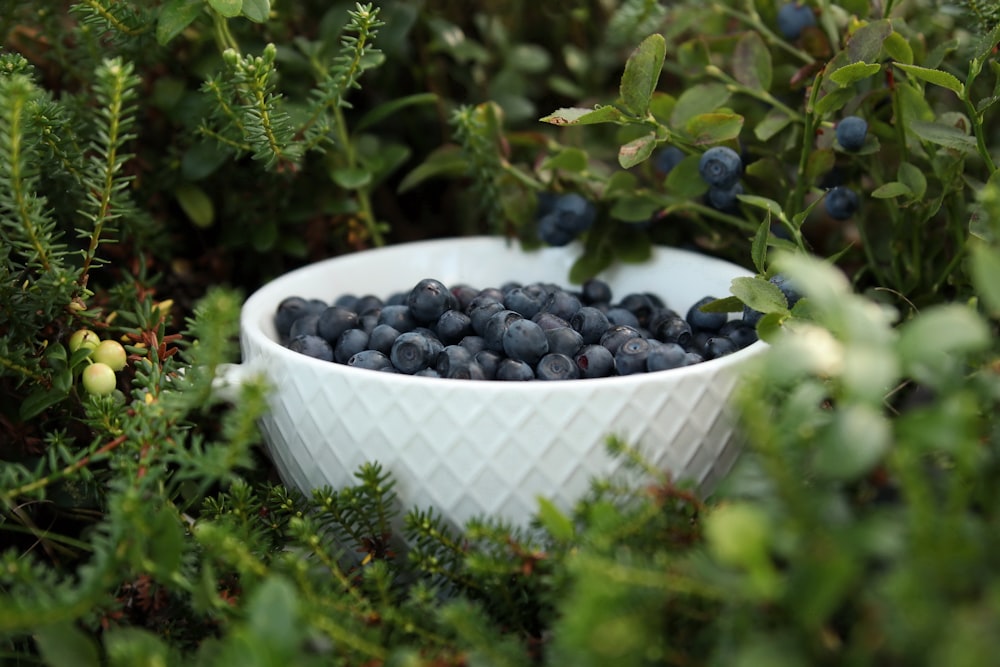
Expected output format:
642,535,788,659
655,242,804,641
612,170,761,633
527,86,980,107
240,236,767,393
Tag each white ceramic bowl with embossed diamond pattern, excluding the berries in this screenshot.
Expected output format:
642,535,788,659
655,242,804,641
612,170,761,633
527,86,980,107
230,237,764,525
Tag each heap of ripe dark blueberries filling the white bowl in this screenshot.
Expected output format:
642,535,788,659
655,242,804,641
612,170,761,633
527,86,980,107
274,278,757,380
